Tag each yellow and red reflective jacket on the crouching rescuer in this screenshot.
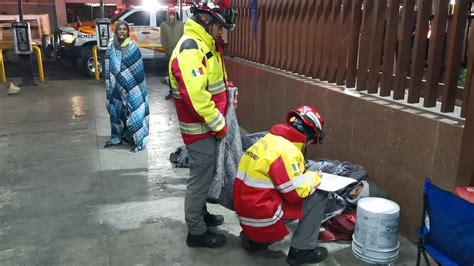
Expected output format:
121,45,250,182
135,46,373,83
234,125,320,243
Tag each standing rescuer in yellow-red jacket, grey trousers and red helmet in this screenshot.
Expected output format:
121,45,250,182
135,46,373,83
169,0,236,248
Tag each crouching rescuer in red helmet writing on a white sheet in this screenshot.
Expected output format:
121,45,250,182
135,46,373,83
234,106,328,265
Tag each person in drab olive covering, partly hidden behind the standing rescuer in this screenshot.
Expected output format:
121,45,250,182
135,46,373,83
160,6,184,100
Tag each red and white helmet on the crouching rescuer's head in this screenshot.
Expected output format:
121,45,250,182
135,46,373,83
286,105,325,143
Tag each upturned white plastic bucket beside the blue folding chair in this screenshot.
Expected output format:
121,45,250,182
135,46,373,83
352,197,400,264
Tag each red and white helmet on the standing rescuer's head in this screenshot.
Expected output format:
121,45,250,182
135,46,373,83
191,0,237,30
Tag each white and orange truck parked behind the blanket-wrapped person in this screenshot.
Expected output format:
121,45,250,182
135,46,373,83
42,5,191,76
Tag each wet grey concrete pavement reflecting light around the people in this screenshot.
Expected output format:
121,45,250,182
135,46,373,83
0,78,416,266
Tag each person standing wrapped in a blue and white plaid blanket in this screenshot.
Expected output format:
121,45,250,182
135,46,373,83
104,21,150,152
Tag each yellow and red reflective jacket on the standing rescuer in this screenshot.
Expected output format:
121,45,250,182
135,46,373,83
169,19,228,145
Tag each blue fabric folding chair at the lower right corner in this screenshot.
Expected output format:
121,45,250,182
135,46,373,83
416,178,474,266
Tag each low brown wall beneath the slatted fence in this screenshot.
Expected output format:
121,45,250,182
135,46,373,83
226,58,463,240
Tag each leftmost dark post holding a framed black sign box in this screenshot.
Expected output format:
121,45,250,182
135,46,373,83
12,0,35,86
